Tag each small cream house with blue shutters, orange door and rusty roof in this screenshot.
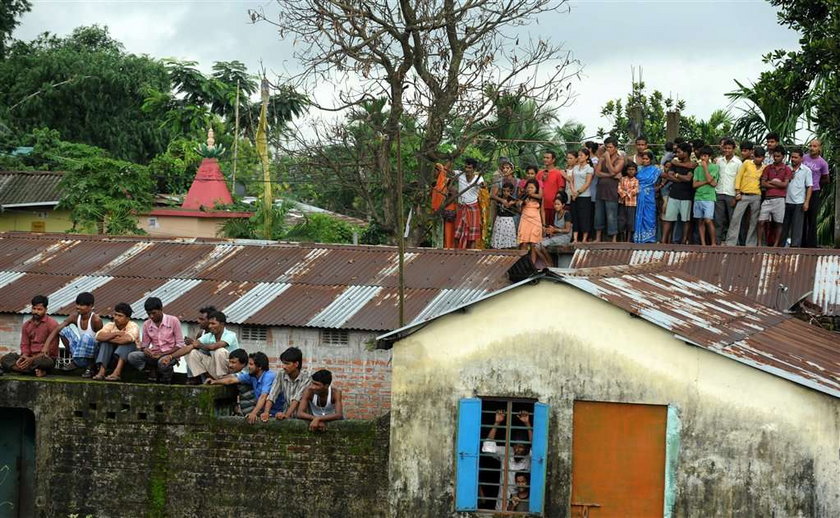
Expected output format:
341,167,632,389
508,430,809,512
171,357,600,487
378,265,840,518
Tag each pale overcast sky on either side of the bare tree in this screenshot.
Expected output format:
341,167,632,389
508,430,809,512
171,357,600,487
15,0,798,140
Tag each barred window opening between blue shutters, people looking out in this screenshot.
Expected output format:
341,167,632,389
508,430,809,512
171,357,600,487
478,398,534,515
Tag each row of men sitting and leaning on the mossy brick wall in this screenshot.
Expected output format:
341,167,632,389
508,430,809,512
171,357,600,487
0,292,344,431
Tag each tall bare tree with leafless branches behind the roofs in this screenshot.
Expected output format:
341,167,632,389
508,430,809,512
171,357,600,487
251,0,578,244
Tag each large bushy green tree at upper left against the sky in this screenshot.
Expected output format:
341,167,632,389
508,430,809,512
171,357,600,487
0,25,169,163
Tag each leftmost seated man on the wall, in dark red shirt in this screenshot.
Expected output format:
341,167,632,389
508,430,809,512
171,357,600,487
0,295,58,378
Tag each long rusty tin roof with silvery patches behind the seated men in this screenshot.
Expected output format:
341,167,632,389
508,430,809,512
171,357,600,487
0,233,522,331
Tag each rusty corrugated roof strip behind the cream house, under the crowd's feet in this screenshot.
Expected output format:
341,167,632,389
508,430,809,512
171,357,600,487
571,243,840,315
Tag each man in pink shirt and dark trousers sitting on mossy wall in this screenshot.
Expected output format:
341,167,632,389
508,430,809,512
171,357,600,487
128,297,190,383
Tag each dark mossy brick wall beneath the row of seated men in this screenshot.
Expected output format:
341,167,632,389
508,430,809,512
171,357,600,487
0,375,388,517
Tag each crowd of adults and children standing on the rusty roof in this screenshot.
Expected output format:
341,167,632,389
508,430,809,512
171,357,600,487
432,133,829,265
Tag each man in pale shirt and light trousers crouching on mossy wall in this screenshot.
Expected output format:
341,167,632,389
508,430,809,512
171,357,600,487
185,311,239,385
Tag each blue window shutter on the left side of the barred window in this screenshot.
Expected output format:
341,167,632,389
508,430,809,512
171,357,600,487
455,399,481,511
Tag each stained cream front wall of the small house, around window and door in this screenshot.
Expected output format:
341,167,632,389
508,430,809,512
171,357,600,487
390,281,840,517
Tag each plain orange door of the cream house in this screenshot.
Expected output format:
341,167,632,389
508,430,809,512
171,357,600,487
571,401,668,518
